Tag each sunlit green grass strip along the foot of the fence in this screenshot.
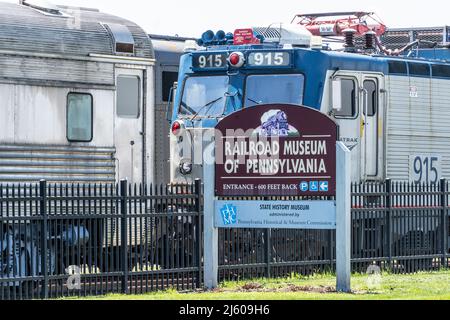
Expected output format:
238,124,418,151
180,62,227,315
64,271,450,300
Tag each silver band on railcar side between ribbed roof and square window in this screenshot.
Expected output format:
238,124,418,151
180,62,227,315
0,55,114,86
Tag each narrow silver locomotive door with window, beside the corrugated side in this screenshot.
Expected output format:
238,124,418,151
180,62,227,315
360,74,384,181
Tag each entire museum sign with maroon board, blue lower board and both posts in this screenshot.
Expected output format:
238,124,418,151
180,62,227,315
203,104,351,292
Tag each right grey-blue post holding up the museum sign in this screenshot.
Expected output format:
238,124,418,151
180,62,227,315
336,142,351,292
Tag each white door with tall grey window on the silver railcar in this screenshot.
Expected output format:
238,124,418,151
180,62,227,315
114,69,144,183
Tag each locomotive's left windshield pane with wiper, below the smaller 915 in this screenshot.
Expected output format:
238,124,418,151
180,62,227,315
179,76,228,118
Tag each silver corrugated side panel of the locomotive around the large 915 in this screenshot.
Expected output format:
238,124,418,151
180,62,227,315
387,76,450,181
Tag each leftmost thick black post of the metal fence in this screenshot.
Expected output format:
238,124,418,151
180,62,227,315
39,180,49,299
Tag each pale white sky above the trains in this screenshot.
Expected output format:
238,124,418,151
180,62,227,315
0,0,450,37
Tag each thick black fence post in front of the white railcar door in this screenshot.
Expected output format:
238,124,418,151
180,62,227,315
120,179,128,294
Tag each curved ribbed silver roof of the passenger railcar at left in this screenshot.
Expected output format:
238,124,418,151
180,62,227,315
0,3,154,58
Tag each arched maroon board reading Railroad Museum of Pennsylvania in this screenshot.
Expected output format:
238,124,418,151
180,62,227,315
215,104,337,196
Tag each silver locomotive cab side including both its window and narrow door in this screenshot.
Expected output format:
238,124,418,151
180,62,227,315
331,71,384,182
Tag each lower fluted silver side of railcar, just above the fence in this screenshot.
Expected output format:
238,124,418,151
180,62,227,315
0,146,116,183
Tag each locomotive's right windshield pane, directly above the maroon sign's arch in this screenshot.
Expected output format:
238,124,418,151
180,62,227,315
245,74,304,107
